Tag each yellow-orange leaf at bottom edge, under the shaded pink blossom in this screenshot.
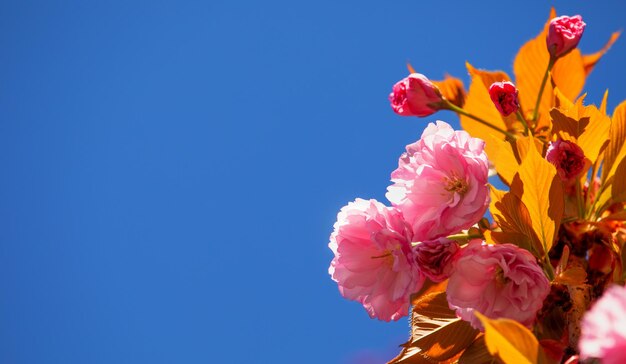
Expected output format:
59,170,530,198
475,311,548,364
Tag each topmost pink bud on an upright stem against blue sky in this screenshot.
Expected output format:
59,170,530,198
546,15,586,59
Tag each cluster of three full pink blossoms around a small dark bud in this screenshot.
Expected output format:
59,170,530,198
329,121,549,328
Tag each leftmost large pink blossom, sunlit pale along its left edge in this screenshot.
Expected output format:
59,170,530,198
328,199,424,321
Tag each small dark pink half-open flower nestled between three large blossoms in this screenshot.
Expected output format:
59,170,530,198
413,238,460,282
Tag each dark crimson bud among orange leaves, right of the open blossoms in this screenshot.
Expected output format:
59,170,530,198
546,139,585,181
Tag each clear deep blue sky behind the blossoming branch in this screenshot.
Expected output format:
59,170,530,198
0,0,626,364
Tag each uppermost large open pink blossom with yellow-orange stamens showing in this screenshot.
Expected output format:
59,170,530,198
386,121,489,241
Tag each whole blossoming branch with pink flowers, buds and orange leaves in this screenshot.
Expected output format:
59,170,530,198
329,10,626,363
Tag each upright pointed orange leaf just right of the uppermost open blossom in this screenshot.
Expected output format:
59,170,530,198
513,142,564,251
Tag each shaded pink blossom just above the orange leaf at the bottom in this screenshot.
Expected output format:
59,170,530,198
447,240,550,330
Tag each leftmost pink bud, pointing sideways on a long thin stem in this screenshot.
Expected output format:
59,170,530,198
389,73,443,116
